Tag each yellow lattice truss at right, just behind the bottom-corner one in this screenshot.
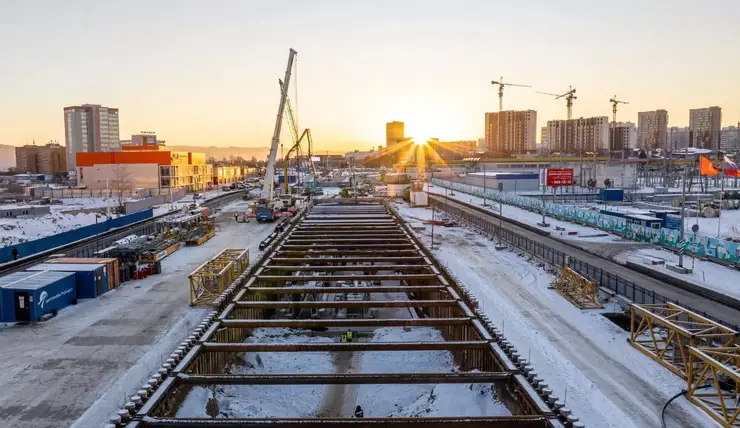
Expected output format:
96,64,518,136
630,303,738,379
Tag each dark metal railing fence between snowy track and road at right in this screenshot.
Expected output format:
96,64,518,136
429,195,740,331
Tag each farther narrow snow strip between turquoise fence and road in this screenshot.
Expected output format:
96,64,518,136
429,186,623,242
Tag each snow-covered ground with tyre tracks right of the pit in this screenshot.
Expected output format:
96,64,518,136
396,204,717,428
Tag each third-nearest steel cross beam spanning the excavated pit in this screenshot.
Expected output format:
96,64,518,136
201,340,490,352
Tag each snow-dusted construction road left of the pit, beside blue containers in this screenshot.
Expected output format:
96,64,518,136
0,202,274,428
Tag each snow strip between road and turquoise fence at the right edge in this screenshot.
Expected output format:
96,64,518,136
614,248,740,299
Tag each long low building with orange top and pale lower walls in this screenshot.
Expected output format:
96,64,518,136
76,145,213,191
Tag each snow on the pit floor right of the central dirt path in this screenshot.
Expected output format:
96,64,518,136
356,327,511,417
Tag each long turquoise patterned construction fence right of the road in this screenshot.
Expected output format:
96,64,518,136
432,178,740,266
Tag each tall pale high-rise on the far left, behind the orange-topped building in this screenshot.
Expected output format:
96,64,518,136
64,104,121,169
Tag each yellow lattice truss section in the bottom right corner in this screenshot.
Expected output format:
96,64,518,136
686,346,740,427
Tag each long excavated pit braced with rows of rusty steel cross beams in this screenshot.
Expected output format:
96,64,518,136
117,199,564,428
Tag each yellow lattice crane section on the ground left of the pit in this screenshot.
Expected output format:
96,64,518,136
188,248,249,306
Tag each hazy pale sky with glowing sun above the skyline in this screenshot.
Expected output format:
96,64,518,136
0,0,740,151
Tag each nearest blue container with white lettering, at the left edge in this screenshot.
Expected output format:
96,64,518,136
0,271,77,322
